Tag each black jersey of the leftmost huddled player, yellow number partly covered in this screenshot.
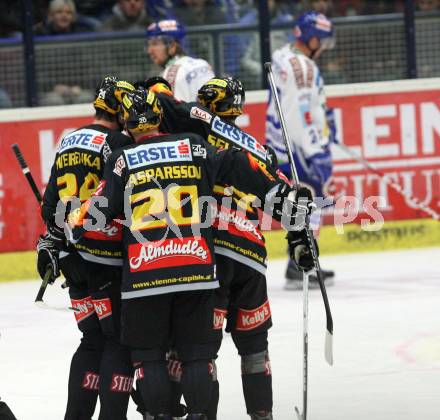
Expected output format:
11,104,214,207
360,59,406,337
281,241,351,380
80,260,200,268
41,124,133,265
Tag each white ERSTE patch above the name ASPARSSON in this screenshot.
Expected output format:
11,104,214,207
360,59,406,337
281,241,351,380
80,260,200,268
124,139,192,169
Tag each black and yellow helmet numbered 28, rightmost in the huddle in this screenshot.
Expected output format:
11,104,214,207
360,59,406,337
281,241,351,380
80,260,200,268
197,76,245,117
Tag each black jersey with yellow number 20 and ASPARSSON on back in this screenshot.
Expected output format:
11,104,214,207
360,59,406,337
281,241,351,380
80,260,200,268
73,133,286,299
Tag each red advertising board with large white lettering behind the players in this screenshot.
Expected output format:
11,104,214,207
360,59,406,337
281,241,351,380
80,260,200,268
0,78,440,256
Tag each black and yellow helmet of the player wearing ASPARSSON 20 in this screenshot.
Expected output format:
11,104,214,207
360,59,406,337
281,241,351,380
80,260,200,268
122,88,162,133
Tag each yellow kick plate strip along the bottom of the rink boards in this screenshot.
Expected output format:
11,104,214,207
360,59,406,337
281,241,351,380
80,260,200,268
0,219,440,282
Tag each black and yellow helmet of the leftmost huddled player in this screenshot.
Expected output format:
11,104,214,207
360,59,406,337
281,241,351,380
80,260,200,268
93,76,135,115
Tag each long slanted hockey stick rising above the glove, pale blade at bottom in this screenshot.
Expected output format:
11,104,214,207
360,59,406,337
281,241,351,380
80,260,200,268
264,62,333,365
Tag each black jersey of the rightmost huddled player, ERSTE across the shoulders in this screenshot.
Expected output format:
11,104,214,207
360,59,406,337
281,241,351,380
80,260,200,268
158,94,276,274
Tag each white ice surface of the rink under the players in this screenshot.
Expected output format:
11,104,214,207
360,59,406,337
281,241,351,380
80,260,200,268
0,248,440,420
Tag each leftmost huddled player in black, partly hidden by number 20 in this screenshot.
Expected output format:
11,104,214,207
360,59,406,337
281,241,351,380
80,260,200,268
37,77,134,420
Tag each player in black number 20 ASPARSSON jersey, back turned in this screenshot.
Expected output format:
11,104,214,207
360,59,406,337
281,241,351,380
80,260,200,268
69,90,312,419
